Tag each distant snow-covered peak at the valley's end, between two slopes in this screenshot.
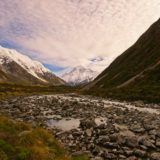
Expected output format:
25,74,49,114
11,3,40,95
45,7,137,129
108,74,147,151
60,66,98,86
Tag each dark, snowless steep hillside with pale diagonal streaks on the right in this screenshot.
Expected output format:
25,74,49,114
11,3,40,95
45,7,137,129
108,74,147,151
85,19,160,100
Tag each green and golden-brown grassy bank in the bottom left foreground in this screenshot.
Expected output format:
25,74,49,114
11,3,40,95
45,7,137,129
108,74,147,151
0,116,88,160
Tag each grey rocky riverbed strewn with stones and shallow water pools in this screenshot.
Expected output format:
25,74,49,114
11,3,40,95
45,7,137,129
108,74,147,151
0,95,160,160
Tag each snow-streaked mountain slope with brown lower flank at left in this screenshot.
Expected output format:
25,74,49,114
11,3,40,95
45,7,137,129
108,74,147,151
0,46,65,85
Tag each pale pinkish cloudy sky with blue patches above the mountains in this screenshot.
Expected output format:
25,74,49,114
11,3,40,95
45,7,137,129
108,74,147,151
0,0,160,72
